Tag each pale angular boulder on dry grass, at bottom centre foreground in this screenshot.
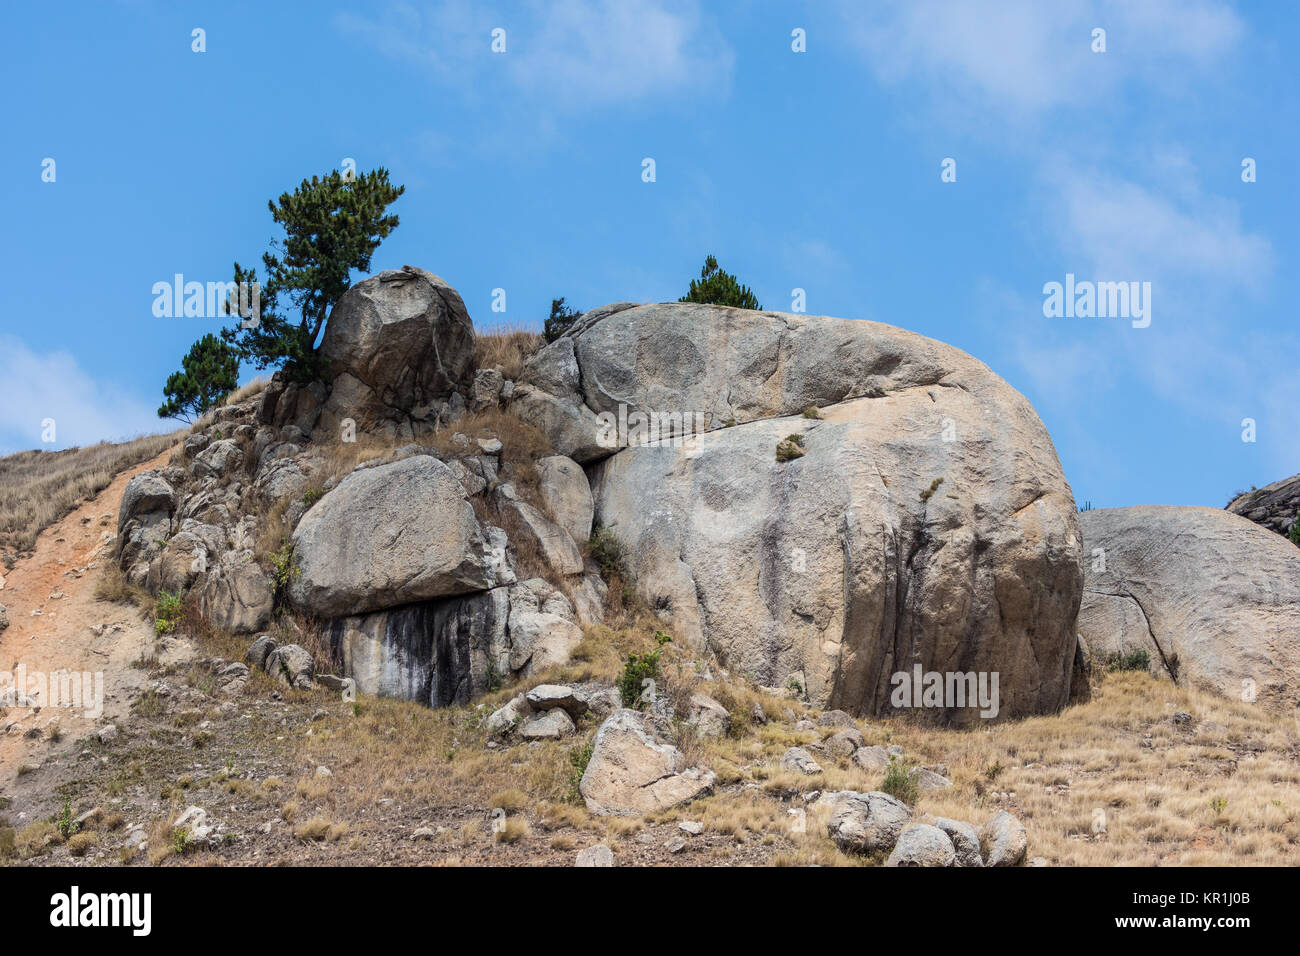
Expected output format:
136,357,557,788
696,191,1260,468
579,710,715,816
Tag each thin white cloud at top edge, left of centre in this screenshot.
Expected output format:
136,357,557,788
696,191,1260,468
335,0,735,112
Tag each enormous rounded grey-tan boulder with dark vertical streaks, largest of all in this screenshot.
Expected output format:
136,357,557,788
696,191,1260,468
582,304,1083,724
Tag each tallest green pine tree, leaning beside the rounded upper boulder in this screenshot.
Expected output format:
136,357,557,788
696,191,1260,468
221,169,406,381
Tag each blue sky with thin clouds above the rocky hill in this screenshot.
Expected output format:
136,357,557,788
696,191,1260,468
0,0,1300,507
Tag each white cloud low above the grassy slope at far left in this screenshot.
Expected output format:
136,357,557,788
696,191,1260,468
0,336,166,454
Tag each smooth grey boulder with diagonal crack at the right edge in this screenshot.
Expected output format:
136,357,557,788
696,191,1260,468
1079,506,1300,708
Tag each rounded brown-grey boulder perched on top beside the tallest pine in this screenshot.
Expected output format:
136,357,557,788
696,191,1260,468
321,265,475,433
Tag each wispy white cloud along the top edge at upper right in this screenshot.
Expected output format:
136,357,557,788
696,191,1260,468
842,0,1243,117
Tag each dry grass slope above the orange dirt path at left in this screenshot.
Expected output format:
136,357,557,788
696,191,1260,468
0,432,179,567
